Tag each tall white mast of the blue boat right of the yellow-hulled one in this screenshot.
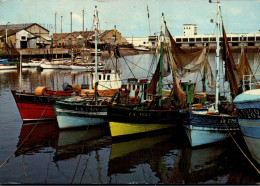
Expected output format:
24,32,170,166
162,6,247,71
215,0,220,113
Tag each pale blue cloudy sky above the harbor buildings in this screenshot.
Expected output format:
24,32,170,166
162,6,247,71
0,0,260,37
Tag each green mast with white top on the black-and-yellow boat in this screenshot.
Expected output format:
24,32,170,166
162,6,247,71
158,13,164,107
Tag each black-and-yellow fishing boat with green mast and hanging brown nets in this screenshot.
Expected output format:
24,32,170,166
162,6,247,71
108,15,197,138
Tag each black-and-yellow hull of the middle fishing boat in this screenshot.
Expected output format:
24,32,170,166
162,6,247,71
108,106,180,137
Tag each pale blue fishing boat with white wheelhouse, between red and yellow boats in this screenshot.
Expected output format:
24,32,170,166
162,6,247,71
54,6,121,129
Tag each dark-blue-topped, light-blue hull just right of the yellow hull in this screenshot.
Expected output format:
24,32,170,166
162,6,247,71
184,111,239,147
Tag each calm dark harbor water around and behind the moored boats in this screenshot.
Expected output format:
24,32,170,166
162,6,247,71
0,54,260,184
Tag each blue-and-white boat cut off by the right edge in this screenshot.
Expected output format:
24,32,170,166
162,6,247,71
234,75,260,164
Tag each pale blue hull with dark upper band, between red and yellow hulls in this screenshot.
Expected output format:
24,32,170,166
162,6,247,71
54,101,107,129
